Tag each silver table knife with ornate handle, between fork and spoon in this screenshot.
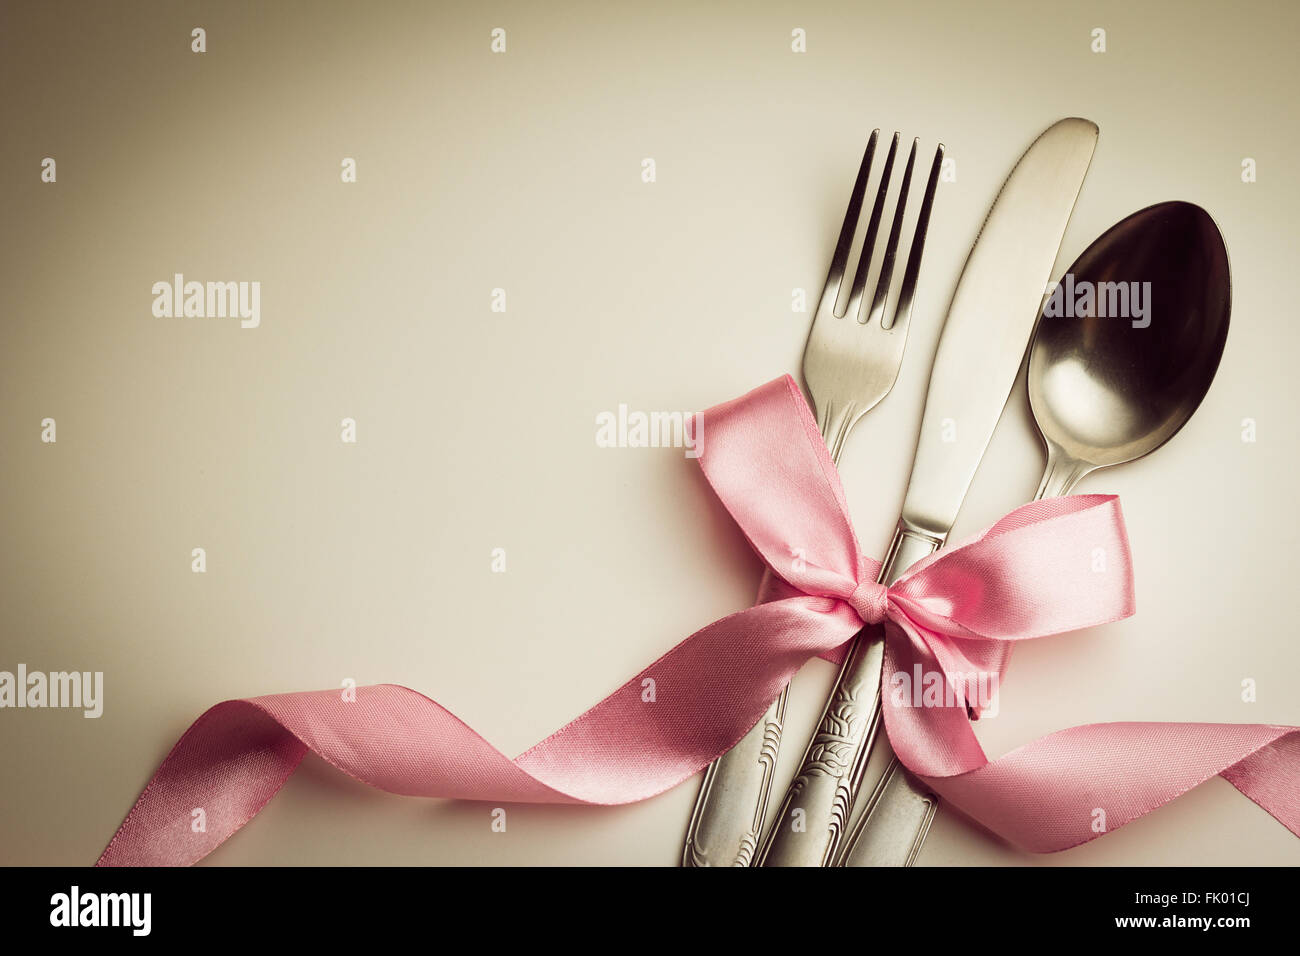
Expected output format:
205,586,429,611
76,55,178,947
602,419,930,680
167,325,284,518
759,117,1097,866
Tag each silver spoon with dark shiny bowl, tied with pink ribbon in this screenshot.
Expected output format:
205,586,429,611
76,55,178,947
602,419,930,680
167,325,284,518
840,202,1232,866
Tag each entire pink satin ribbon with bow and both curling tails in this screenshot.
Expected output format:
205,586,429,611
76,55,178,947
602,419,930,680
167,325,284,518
99,376,1300,865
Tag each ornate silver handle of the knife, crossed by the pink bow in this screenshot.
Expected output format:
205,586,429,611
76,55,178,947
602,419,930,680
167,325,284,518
759,523,943,866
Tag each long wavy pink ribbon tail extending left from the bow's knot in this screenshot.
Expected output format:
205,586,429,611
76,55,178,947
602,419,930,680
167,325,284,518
99,596,861,866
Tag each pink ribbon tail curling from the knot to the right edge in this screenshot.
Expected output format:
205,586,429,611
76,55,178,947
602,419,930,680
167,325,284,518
883,582,1300,853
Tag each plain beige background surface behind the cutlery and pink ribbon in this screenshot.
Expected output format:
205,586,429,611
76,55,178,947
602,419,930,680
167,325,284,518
0,0,1300,865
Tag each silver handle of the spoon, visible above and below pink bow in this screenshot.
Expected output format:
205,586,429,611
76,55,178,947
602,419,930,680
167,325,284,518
837,445,1093,866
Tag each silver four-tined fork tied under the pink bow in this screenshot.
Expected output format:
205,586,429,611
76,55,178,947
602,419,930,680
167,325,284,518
683,130,944,866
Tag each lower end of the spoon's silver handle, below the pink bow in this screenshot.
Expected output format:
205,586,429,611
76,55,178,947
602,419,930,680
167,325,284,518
839,754,939,866
